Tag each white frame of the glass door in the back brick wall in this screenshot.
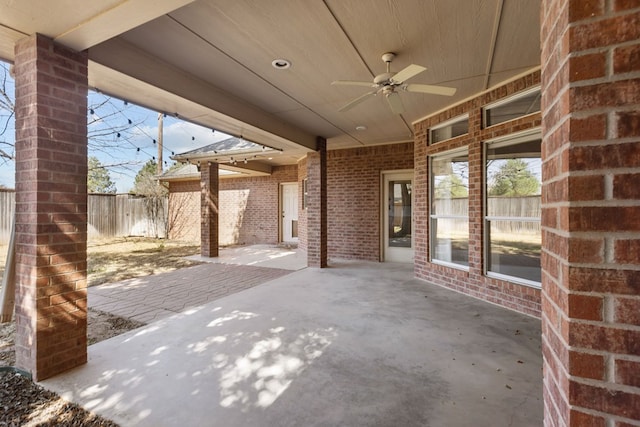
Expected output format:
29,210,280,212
380,169,415,263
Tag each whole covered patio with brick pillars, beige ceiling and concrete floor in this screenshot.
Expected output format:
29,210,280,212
0,0,640,427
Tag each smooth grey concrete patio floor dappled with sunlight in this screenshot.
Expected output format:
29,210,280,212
41,251,542,427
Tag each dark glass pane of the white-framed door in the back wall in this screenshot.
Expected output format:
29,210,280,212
388,181,412,248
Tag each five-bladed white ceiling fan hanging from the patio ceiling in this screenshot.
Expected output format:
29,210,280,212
331,52,456,114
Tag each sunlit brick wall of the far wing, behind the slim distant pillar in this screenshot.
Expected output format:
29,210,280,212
169,165,302,246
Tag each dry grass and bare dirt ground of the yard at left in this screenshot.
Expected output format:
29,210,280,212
0,237,200,427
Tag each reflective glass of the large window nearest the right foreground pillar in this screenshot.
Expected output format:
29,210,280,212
485,139,542,286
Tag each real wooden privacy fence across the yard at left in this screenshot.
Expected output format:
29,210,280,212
0,190,168,245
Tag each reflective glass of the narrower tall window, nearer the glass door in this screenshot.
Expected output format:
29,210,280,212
430,150,469,266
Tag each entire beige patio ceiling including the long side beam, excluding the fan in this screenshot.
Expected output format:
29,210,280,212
0,0,540,169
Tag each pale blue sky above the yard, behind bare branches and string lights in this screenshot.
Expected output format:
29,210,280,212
0,60,229,193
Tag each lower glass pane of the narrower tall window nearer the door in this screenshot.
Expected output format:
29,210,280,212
431,218,469,266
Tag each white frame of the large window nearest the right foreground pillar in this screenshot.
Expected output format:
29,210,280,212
482,127,542,289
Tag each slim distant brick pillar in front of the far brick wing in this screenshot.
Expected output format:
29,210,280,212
200,163,219,258
